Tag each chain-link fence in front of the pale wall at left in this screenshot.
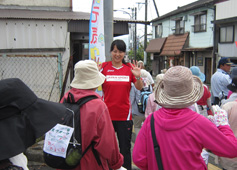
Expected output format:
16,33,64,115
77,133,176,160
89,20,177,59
0,54,63,102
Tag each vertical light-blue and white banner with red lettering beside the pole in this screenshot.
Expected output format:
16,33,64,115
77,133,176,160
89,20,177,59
89,0,105,96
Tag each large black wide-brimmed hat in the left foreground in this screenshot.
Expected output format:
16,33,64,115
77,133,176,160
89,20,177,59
0,78,71,160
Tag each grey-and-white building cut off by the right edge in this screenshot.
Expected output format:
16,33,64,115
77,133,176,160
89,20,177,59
214,0,237,65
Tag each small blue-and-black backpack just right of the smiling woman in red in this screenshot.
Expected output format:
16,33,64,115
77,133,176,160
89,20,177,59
137,85,152,114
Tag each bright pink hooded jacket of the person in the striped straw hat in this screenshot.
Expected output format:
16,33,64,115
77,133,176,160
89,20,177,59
133,108,237,170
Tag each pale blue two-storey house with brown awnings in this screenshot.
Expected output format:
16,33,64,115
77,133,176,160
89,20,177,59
147,0,215,83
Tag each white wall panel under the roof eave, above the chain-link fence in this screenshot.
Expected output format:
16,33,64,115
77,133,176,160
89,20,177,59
0,20,69,49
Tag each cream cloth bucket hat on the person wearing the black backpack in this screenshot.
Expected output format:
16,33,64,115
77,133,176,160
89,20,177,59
70,60,105,89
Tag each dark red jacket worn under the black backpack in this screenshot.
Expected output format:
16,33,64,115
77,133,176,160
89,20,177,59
58,88,123,170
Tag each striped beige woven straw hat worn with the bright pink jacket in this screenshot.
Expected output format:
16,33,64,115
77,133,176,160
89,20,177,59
155,66,203,108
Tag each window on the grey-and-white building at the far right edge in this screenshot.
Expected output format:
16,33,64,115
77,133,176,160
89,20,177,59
220,25,234,43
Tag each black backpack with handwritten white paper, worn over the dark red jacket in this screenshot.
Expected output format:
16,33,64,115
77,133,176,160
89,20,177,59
43,92,101,169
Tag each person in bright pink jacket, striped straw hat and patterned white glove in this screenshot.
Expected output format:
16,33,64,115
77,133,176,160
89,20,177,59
132,66,237,170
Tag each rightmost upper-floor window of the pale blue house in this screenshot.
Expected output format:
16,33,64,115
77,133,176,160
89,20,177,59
193,13,207,32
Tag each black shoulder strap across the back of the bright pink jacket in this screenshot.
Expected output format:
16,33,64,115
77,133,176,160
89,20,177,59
151,114,164,170
